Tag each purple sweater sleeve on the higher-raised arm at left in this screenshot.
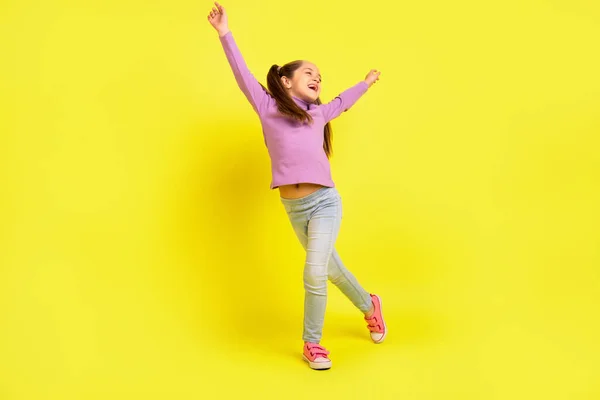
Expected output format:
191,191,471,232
219,31,274,115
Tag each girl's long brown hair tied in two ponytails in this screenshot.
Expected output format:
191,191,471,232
263,60,333,158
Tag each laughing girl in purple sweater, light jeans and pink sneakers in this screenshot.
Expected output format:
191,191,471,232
208,2,386,369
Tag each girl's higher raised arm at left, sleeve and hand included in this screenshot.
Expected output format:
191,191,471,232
208,2,274,115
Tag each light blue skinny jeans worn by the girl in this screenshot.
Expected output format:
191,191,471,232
280,187,372,343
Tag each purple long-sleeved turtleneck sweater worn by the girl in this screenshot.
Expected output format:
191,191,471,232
219,32,369,189
